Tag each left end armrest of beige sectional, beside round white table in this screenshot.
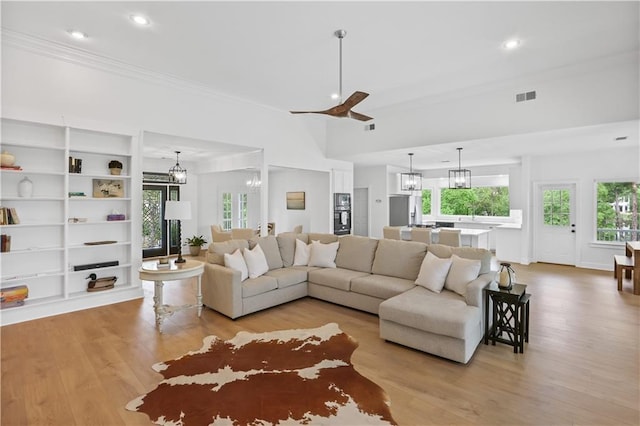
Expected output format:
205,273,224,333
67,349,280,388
202,263,242,319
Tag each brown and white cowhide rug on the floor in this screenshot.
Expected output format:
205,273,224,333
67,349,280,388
127,323,395,425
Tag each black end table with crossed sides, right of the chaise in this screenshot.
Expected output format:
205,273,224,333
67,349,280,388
484,282,531,353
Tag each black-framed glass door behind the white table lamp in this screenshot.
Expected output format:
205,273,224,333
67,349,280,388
142,185,180,258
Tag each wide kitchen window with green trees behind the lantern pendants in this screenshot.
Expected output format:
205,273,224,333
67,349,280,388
440,186,509,216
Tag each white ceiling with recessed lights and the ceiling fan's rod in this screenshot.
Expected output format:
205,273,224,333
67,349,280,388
1,1,639,168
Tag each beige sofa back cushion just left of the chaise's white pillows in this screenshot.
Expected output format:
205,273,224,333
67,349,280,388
371,239,427,281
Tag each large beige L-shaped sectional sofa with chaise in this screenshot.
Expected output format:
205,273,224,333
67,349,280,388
202,233,494,363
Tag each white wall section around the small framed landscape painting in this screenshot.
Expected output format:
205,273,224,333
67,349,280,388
268,170,333,233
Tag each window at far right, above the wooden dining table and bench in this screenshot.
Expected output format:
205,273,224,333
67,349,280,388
596,182,640,242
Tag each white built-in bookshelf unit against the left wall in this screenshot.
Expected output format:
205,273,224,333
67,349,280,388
0,119,142,324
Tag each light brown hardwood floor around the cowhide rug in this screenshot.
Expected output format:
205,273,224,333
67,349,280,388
0,264,640,426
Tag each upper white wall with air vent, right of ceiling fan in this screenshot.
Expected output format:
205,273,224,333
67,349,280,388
327,51,640,158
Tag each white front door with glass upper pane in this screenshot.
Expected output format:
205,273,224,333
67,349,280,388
534,184,576,266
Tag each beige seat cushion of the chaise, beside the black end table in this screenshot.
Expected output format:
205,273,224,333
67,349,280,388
379,286,482,339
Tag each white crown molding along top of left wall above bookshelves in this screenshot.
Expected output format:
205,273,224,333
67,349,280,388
0,28,281,111
